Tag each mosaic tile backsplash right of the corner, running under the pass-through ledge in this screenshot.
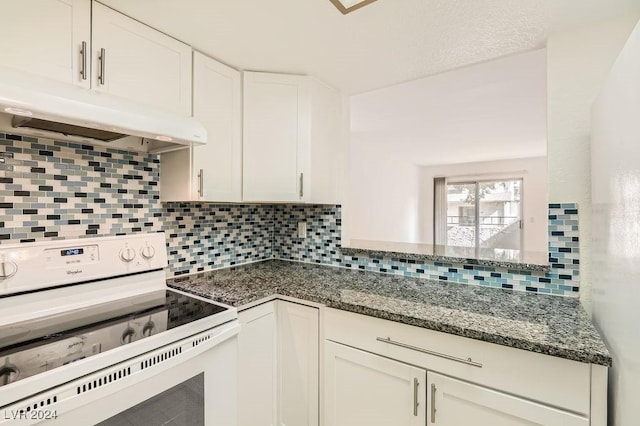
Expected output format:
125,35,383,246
273,204,580,297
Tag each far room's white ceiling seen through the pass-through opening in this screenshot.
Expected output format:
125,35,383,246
350,49,547,166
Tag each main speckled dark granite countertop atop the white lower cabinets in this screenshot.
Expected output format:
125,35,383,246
167,260,611,366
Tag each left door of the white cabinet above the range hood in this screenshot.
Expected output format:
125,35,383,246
0,0,91,88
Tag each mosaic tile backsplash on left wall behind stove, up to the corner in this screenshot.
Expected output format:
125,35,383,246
0,133,273,275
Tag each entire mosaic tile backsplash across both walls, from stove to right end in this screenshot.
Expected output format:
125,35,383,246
0,133,579,297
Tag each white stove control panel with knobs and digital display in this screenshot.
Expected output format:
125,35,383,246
0,232,167,295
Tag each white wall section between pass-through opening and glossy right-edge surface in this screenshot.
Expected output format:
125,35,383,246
547,14,640,312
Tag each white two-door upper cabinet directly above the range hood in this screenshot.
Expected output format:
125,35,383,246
0,0,191,116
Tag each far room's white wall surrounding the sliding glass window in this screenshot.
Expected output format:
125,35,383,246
420,157,549,252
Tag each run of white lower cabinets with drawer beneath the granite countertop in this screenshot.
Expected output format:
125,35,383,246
238,300,606,426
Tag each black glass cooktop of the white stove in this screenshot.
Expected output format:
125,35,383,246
0,290,228,386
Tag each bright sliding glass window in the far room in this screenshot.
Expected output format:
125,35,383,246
436,179,522,250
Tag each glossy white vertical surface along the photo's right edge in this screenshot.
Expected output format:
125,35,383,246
591,18,640,426
